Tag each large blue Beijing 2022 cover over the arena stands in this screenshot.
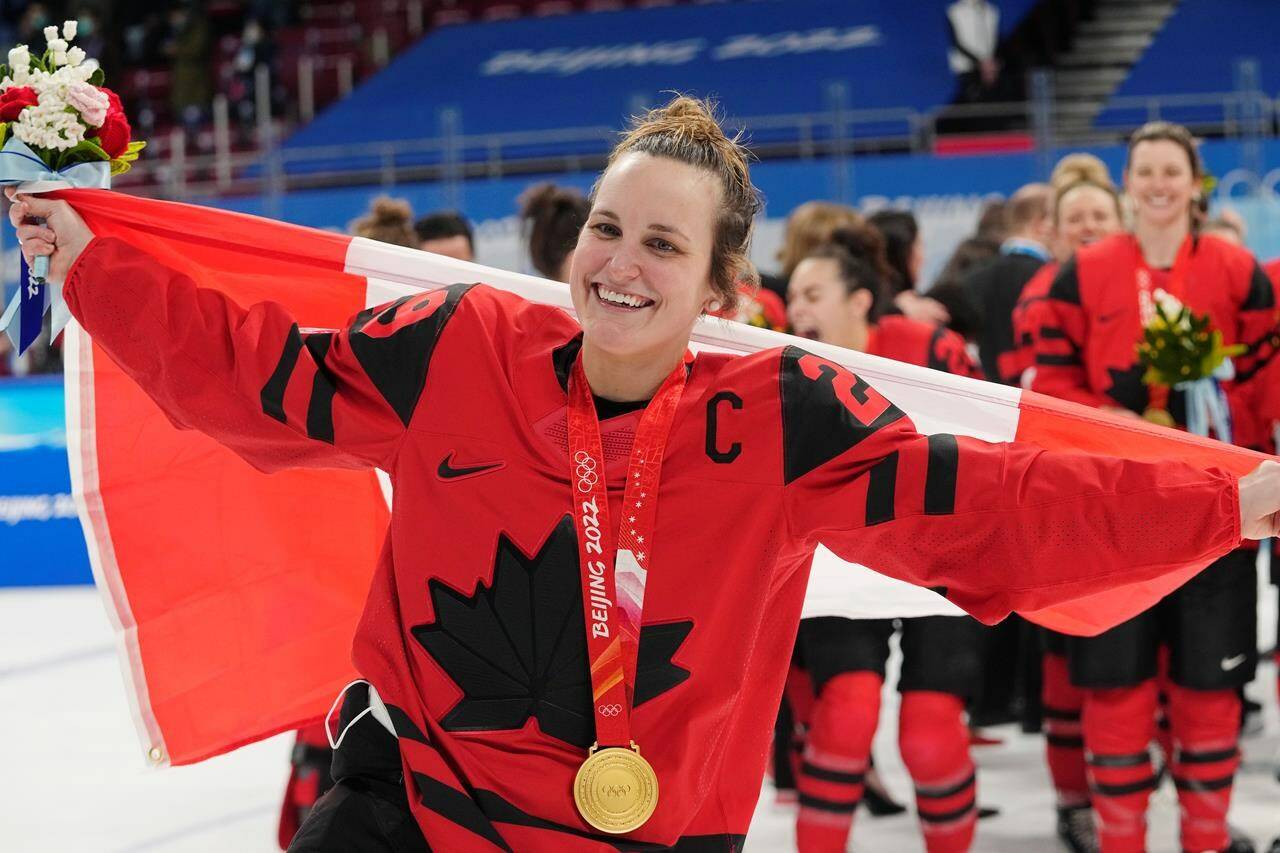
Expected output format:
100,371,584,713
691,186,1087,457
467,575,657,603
277,0,1036,167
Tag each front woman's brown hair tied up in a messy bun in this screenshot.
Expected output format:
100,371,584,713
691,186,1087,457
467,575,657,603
591,95,763,314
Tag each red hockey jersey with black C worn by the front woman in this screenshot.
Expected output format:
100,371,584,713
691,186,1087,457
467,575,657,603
64,237,1240,852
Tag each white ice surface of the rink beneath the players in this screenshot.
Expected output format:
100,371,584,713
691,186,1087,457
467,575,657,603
0,587,1280,853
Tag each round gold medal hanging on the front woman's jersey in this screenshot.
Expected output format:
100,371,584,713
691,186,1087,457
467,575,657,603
573,742,658,835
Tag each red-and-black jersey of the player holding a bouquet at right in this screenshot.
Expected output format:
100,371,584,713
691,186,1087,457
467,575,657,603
1032,234,1280,450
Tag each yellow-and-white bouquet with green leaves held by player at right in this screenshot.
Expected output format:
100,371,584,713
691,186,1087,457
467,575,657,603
1138,289,1244,442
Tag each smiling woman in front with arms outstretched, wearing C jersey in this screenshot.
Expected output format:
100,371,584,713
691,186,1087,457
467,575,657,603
10,99,1280,852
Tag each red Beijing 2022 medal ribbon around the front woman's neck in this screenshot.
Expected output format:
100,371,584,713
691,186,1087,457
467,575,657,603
568,352,692,748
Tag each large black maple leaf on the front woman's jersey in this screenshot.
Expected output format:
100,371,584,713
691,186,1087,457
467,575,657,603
411,515,694,748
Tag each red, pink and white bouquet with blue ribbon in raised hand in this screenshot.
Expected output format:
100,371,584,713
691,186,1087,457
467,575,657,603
0,20,146,352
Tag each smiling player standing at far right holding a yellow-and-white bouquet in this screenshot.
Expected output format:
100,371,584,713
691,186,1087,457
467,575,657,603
1032,123,1280,853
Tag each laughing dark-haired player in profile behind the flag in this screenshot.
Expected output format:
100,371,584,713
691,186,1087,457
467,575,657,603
787,232,982,853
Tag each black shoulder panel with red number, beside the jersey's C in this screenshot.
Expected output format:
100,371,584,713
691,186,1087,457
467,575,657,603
781,347,905,483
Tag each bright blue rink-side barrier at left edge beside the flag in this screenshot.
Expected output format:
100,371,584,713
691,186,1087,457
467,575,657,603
0,377,93,587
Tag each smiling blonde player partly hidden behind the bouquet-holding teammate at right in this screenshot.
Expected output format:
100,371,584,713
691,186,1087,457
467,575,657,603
1014,154,1123,853
